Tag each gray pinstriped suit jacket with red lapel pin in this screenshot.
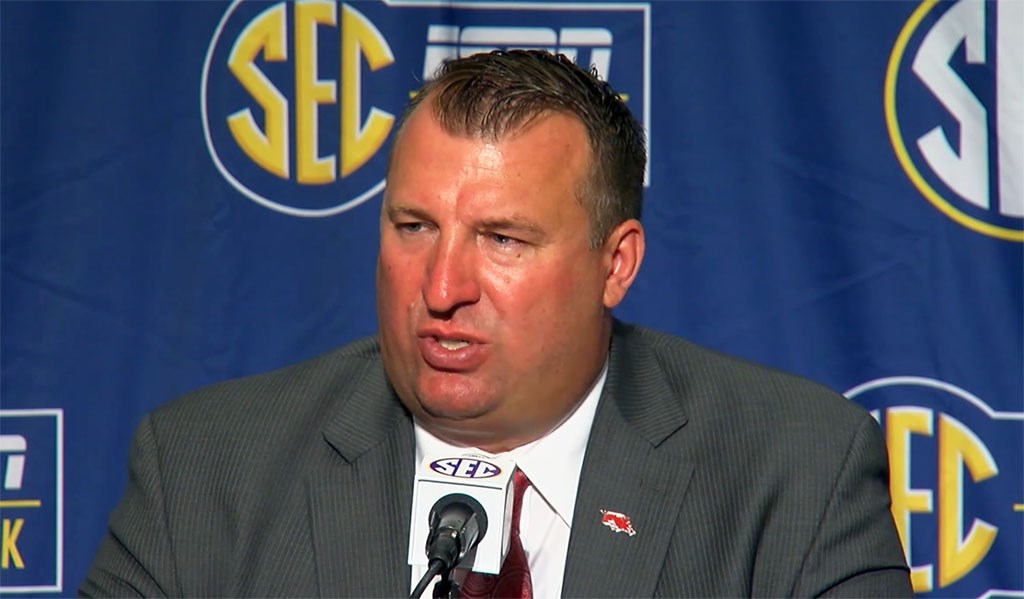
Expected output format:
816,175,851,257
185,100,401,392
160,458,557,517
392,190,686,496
80,323,910,597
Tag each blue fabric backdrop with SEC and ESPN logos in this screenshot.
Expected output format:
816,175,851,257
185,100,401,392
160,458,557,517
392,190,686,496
0,0,1024,597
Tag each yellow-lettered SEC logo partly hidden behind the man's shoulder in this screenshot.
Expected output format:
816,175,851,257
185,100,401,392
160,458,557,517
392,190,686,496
845,377,1024,597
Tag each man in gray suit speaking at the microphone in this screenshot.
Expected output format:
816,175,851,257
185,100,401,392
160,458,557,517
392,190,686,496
81,51,910,597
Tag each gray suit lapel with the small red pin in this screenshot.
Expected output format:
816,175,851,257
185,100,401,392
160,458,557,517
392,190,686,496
562,323,693,597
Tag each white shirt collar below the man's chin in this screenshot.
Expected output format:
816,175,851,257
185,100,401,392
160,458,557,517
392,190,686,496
414,360,608,526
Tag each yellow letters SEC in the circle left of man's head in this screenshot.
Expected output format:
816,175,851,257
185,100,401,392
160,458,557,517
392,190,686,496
227,0,394,185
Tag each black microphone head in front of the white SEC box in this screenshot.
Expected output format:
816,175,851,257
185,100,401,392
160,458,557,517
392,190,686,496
427,493,487,572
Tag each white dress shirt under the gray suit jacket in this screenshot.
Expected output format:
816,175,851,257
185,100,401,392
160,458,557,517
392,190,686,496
410,362,608,597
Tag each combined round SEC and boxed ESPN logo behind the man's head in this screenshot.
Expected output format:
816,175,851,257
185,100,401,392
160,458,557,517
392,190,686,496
200,0,650,217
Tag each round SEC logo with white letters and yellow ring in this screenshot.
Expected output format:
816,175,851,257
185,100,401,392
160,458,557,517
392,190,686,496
884,0,1024,242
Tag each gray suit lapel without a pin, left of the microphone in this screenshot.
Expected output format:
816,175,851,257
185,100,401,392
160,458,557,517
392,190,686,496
308,360,416,597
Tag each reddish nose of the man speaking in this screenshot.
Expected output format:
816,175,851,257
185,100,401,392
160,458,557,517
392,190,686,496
423,237,480,316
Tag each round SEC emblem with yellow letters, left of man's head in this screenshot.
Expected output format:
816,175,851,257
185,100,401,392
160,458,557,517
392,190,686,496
201,1,402,216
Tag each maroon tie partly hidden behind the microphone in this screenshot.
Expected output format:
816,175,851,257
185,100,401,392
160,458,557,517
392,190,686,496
461,468,534,599
